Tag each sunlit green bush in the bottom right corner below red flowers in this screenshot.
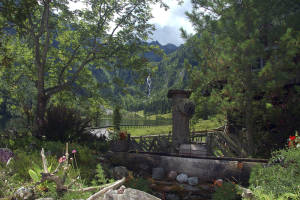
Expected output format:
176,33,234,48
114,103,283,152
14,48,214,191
249,148,300,200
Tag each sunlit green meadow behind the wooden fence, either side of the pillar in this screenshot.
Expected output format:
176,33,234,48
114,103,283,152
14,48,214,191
126,114,223,136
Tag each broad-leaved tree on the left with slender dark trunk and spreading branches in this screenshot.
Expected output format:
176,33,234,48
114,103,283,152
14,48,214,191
0,0,171,136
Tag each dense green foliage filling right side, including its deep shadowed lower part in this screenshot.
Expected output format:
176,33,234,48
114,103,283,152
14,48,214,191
183,0,300,157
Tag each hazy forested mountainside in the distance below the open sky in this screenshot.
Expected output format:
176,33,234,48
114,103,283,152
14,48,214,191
94,41,195,114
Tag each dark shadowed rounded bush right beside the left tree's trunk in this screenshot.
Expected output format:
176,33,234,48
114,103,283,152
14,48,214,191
44,105,89,142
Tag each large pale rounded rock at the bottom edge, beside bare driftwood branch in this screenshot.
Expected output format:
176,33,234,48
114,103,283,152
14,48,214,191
103,188,161,200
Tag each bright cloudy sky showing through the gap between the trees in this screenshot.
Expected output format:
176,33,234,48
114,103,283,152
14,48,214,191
70,0,195,46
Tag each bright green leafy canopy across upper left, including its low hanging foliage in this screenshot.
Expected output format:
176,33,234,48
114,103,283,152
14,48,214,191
0,0,168,136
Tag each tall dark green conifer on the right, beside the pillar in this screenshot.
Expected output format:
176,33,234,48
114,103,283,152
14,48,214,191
182,0,300,155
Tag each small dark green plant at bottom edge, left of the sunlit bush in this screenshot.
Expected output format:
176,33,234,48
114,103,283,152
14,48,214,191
212,182,240,200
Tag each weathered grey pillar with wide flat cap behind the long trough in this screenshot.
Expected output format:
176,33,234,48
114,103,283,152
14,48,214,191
168,90,195,151
